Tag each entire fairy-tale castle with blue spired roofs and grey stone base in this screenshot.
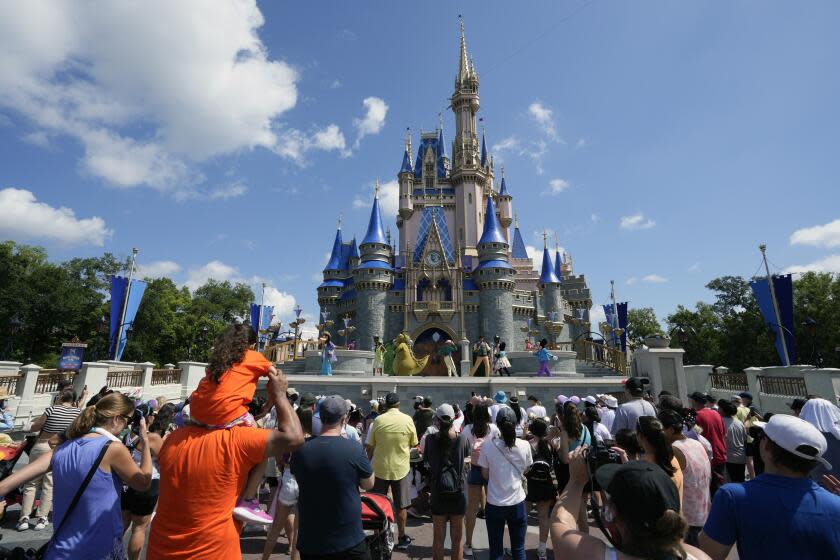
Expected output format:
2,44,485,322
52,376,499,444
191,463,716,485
318,23,592,374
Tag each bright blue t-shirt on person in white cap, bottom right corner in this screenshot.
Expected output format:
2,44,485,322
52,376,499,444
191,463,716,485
703,473,840,560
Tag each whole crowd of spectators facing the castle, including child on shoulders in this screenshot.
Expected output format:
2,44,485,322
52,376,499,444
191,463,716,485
0,325,840,560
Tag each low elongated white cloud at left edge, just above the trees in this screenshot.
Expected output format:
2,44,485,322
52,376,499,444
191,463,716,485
0,188,114,247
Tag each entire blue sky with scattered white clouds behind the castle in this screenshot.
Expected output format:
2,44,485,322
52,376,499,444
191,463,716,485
0,1,840,328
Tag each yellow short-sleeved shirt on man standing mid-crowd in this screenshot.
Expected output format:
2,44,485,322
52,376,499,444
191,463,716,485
368,408,418,480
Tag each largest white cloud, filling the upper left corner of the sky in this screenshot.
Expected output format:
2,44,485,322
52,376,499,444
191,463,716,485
0,0,298,194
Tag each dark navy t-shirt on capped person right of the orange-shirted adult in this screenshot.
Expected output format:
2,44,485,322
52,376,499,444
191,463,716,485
291,436,373,554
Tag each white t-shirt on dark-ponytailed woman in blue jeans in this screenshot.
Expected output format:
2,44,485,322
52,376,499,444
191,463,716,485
478,438,534,507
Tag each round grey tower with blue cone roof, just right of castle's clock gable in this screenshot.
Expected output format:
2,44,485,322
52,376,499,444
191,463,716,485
472,196,516,346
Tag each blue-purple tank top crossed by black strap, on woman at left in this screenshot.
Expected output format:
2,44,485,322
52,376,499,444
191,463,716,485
45,436,125,560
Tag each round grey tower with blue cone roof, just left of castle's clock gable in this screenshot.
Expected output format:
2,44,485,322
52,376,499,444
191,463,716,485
353,181,394,350
